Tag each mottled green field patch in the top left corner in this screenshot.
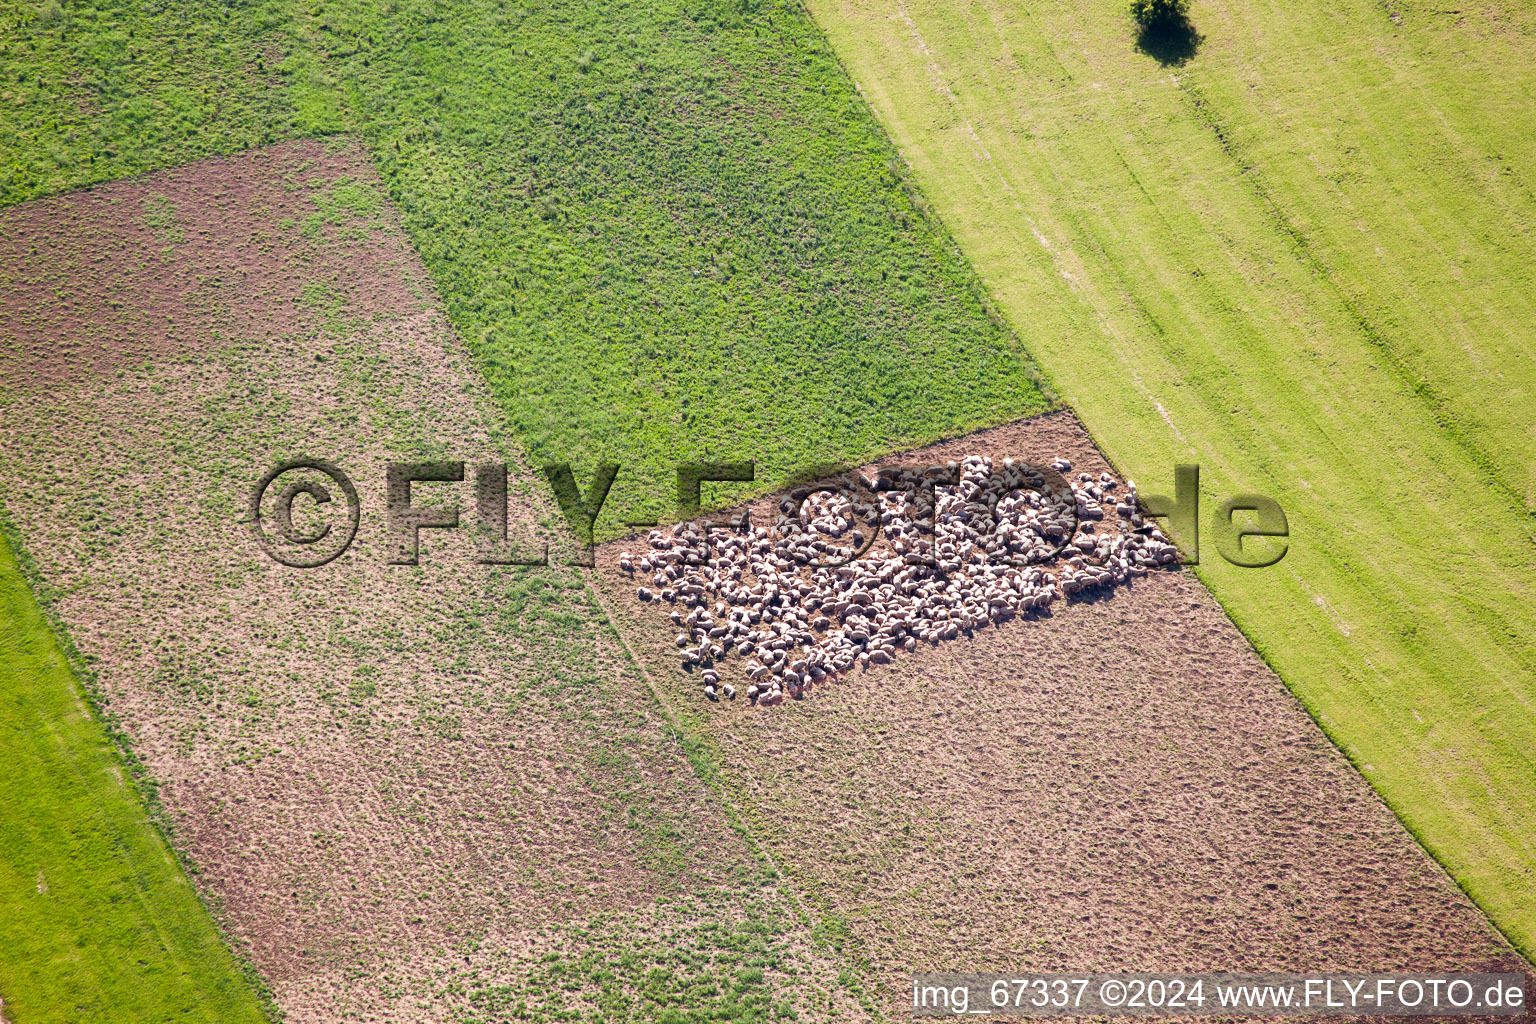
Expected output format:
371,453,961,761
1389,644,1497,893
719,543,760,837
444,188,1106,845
0,0,316,206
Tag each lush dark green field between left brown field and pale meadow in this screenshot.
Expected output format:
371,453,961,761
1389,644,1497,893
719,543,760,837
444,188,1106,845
279,0,1046,536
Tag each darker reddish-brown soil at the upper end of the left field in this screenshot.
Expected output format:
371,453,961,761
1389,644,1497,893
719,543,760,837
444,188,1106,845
0,140,425,388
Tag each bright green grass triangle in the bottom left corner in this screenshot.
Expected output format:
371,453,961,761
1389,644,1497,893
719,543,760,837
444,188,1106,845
0,525,266,1024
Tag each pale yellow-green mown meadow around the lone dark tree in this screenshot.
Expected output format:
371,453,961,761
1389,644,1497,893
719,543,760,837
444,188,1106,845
811,0,1536,956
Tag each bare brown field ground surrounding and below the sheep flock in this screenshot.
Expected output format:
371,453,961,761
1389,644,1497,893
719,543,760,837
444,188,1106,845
594,411,1525,1012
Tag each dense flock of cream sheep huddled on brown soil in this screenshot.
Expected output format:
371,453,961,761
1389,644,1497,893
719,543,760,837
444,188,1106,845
619,456,1178,705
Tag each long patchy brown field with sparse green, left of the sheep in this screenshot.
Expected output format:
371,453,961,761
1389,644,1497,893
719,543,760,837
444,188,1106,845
0,143,865,1021
